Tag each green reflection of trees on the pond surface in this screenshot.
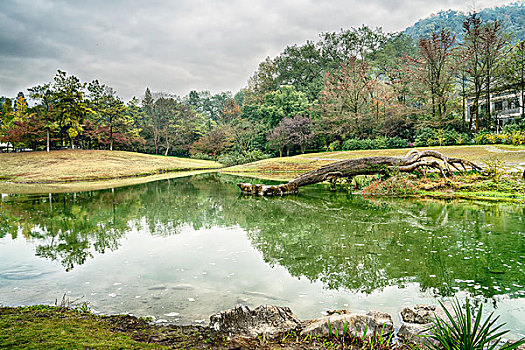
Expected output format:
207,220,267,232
0,174,525,297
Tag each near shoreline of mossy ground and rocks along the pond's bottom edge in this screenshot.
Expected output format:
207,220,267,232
0,302,525,350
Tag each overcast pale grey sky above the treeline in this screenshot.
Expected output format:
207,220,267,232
0,0,513,100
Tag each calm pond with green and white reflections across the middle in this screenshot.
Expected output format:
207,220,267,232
0,174,525,335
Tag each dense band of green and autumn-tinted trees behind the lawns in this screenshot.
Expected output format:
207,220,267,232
0,5,525,164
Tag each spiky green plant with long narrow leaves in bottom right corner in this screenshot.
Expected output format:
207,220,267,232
426,299,525,350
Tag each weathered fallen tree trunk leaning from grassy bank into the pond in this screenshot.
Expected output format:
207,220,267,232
237,150,481,196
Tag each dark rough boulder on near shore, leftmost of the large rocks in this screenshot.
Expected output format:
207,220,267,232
210,305,301,338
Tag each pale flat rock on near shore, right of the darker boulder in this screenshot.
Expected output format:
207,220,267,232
301,311,394,337
